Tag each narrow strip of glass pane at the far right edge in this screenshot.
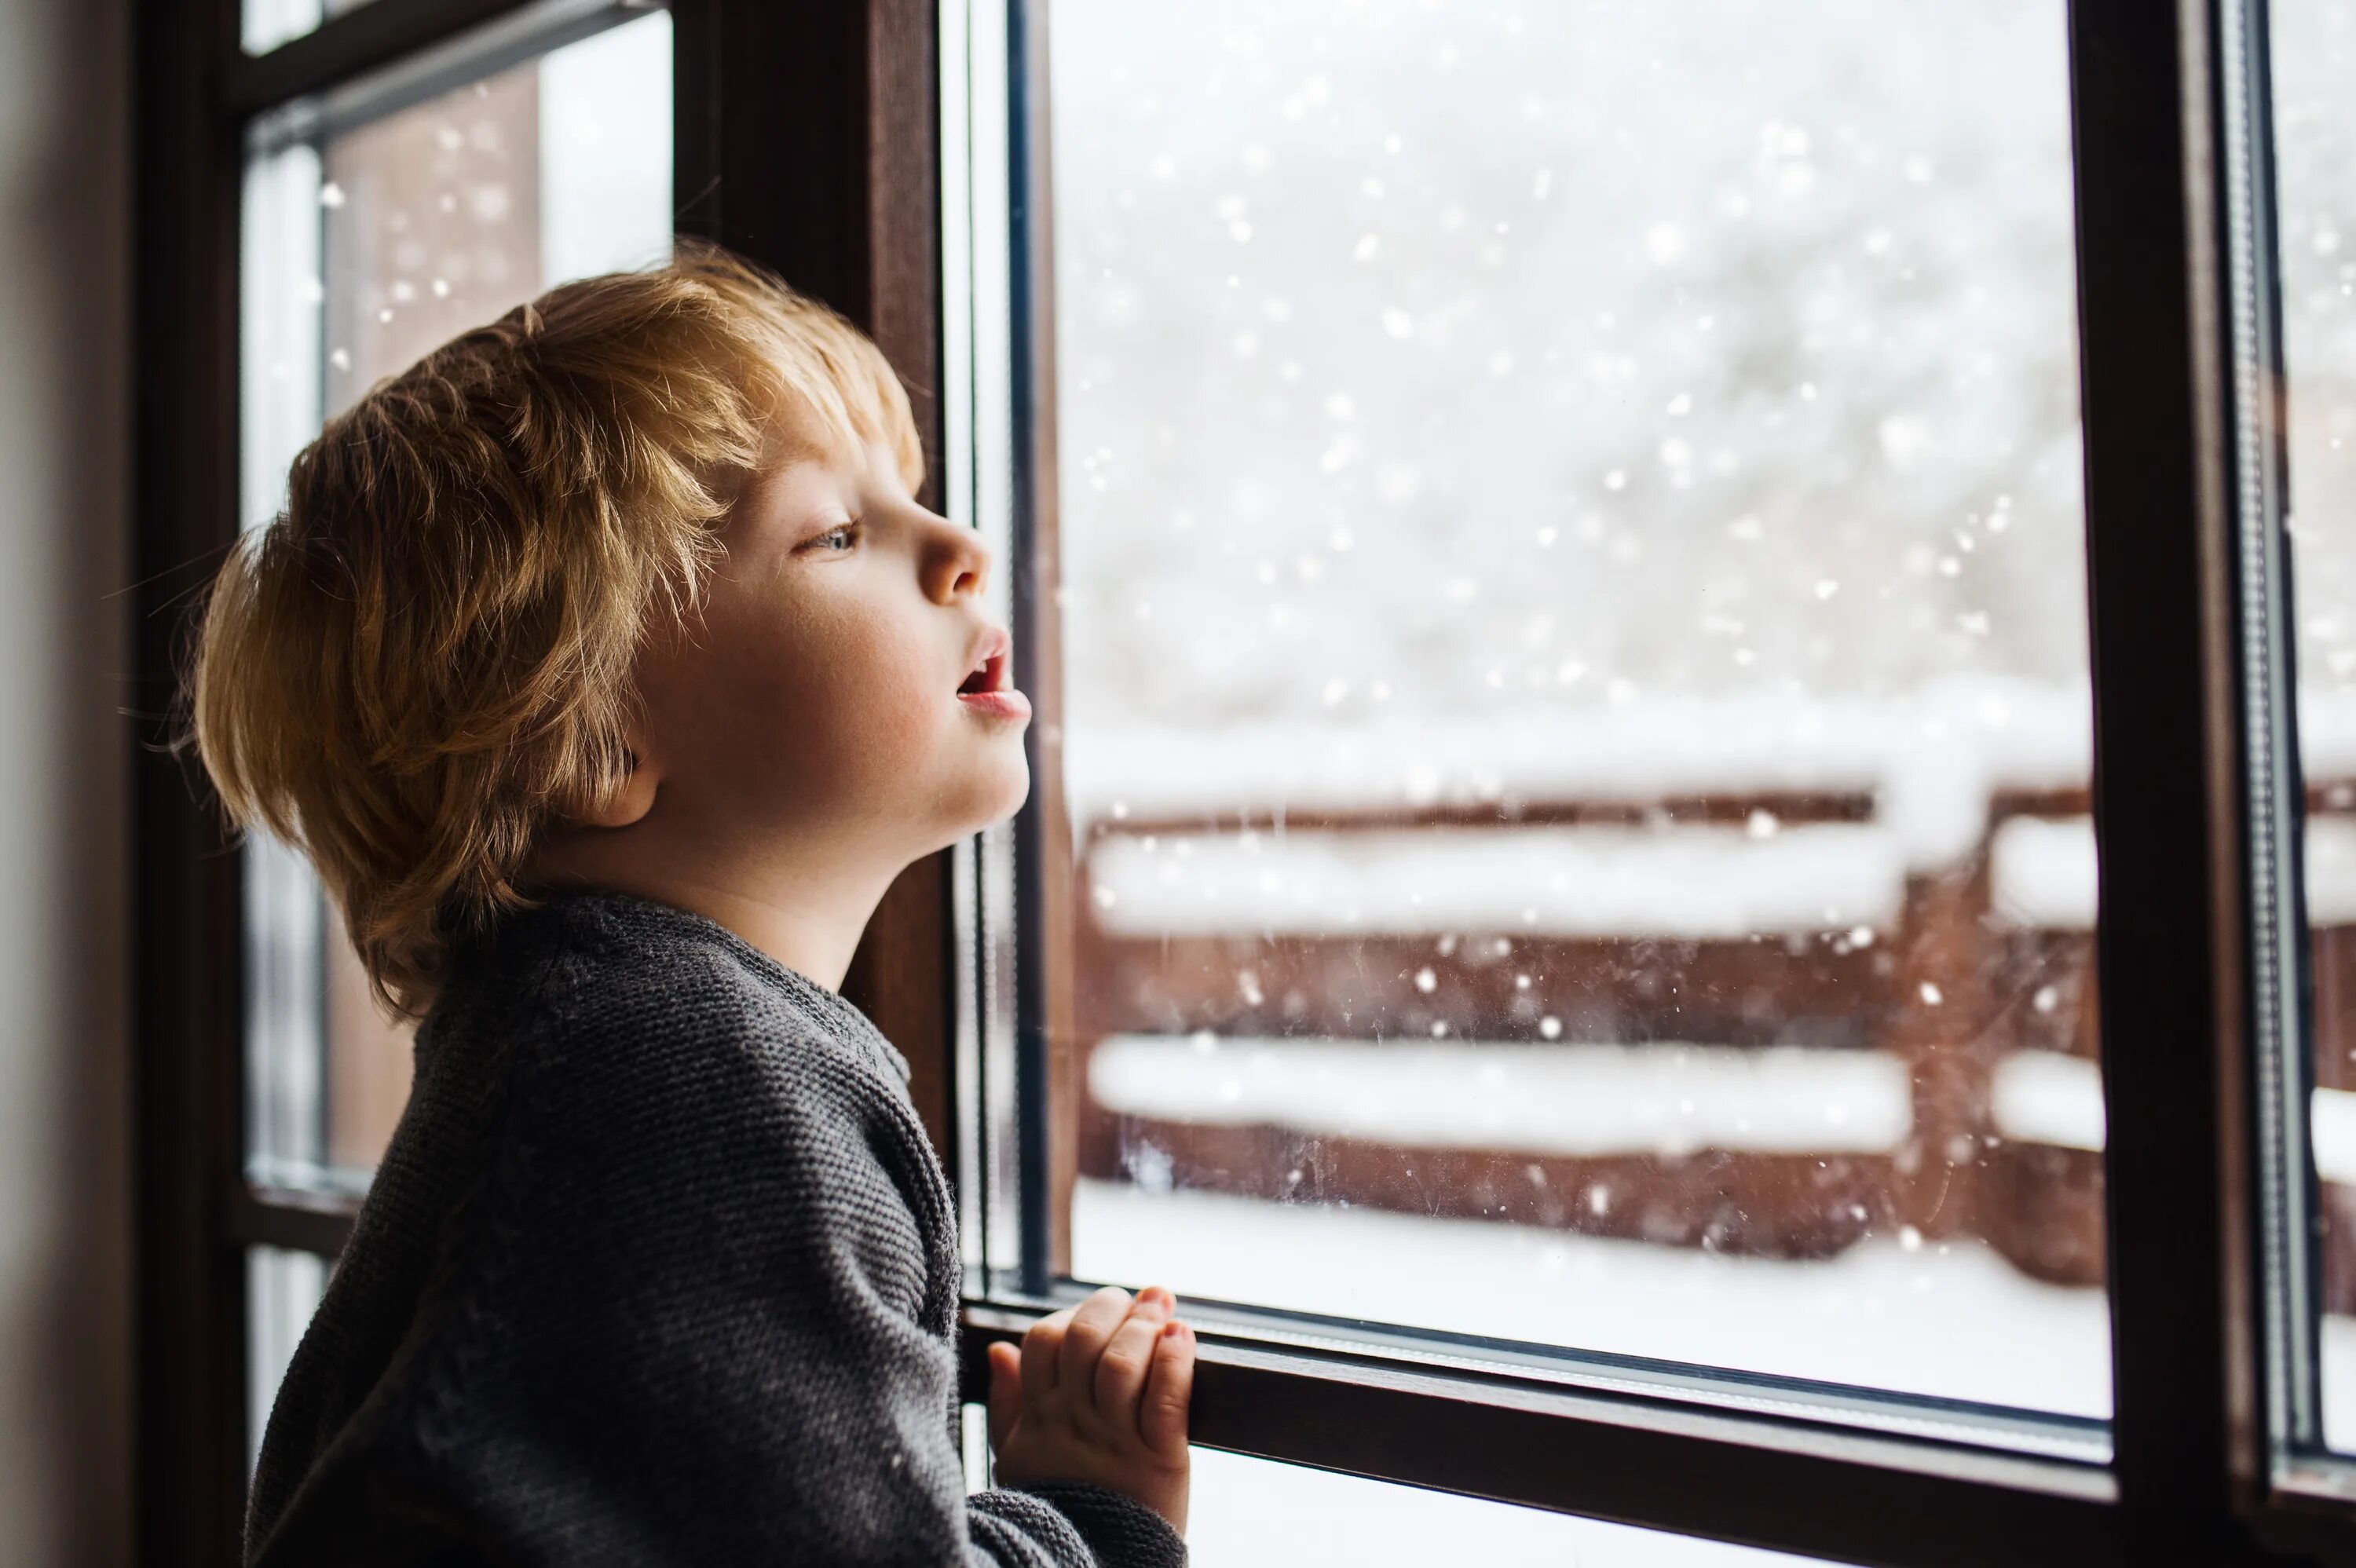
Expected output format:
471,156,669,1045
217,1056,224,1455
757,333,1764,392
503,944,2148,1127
2269,0,2356,1448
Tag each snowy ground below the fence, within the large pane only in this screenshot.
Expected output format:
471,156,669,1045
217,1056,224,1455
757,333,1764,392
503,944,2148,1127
1072,1182,2111,1417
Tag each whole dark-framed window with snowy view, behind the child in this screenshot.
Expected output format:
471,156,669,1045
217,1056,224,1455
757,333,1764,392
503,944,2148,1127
137,0,2356,1566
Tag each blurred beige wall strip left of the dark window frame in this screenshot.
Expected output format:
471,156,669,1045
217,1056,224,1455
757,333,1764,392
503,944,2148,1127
0,0,130,1566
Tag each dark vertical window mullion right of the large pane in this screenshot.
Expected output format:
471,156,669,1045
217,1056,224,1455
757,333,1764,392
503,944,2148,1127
2071,0,2259,1561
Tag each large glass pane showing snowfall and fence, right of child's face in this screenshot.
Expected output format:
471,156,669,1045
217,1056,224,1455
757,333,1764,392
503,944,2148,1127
1041,0,2111,1415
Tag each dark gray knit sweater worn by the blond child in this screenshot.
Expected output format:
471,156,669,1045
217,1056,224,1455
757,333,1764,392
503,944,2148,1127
247,892,1185,1568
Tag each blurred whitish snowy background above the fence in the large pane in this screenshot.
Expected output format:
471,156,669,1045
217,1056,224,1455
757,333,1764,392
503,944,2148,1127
1051,0,2085,730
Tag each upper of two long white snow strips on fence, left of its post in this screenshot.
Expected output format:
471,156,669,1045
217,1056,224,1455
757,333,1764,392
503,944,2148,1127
1088,814,1906,941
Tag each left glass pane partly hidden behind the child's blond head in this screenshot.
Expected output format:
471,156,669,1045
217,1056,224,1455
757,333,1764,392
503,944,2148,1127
240,7,671,1184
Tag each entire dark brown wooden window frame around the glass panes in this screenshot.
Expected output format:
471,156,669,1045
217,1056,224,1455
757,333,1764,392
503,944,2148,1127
132,0,2356,1568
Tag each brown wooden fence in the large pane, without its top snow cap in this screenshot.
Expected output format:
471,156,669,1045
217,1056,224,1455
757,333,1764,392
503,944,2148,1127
1072,791,2099,1278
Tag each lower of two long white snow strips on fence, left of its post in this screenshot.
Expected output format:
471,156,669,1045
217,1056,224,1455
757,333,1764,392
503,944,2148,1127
1088,1033,1913,1156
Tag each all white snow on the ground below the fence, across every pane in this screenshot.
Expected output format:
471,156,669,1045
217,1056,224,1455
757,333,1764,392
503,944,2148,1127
1072,1182,2356,1568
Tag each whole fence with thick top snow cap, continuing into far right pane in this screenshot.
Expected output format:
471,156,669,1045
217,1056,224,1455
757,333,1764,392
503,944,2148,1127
1058,681,2356,1309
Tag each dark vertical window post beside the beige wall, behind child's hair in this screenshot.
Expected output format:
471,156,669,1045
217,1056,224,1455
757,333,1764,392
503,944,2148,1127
130,0,245,1563
